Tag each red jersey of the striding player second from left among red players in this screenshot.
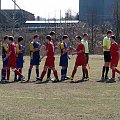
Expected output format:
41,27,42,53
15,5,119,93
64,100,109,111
46,42,54,58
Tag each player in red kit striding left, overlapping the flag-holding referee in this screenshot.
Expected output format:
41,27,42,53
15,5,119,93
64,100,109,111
71,36,89,80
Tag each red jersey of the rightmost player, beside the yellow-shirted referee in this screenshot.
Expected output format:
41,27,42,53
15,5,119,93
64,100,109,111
110,42,119,57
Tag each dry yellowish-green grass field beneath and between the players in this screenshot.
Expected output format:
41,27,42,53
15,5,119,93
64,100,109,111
0,56,120,120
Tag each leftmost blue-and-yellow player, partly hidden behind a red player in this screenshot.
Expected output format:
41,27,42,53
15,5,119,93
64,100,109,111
1,36,9,83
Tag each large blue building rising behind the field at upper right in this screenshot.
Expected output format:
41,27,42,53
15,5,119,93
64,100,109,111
79,0,116,24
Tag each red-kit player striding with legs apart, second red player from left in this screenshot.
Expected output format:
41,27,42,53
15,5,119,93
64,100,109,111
38,35,59,82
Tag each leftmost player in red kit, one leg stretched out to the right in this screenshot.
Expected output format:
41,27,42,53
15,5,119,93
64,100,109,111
4,36,25,81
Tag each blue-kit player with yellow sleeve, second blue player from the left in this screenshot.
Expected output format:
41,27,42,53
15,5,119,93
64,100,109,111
14,36,25,81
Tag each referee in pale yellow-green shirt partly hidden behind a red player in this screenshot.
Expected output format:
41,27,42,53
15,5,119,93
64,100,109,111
81,33,89,80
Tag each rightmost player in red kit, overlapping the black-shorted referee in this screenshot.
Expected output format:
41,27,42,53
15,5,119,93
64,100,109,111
106,35,120,83
